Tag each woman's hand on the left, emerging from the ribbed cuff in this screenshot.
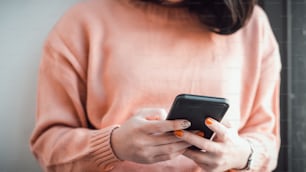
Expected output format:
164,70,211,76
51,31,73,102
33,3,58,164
111,108,191,164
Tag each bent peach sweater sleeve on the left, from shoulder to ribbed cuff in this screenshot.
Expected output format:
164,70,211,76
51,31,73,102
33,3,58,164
30,3,120,172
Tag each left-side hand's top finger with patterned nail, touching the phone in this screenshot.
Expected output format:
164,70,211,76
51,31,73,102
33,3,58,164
145,119,191,134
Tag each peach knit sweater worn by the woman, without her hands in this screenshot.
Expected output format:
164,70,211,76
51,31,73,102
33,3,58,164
31,0,281,172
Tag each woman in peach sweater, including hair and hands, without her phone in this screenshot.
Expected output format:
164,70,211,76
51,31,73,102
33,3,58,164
31,0,281,172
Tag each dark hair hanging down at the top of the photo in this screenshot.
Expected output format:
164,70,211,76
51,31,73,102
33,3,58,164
143,0,256,34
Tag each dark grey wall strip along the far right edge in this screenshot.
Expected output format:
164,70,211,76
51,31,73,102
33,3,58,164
290,0,306,171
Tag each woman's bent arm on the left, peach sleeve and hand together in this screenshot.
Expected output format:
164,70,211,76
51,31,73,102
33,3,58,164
31,37,190,172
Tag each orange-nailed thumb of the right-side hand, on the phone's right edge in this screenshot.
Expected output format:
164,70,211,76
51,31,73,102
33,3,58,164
205,118,229,140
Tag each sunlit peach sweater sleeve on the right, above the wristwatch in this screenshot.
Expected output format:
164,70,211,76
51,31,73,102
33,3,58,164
239,8,281,172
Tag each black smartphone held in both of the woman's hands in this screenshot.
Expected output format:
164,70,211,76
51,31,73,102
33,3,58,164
167,94,229,139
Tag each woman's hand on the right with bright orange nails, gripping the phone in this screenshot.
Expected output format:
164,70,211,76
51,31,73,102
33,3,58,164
175,118,251,172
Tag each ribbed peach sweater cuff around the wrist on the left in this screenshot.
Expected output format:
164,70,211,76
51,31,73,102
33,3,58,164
90,125,121,171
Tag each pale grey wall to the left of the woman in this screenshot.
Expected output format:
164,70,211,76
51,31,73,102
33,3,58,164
0,0,77,172
